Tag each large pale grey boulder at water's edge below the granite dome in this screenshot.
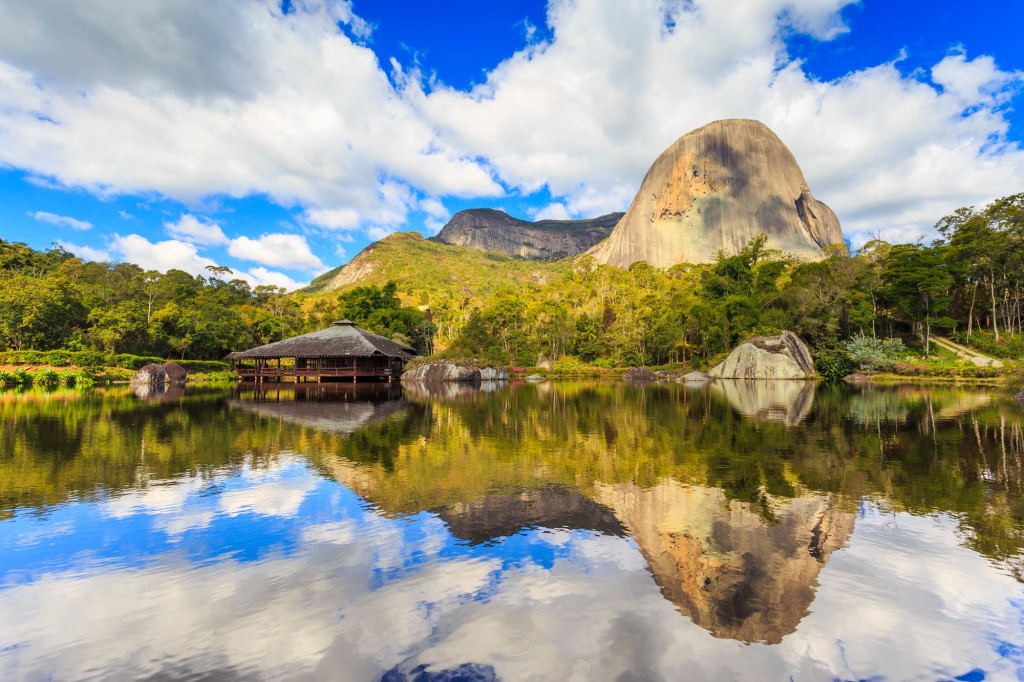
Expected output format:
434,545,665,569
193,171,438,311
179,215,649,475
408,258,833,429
708,332,817,379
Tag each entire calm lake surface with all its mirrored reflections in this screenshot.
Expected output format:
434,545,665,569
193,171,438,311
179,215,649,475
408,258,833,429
0,383,1024,681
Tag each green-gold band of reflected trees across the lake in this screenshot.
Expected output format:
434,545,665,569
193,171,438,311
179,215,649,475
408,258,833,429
0,383,1024,577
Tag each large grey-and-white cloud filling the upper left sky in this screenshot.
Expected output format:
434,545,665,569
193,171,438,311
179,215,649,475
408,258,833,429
0,0,501,238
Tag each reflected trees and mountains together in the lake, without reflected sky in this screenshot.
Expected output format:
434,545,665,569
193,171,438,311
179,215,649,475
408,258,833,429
0,383,1024,641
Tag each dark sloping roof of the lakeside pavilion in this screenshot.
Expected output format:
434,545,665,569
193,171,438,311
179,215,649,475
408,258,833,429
234,319,416,359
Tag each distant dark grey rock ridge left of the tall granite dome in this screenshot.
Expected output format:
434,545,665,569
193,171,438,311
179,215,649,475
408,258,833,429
434,209,623,260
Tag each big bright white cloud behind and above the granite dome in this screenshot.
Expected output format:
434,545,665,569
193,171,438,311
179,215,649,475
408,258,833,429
407,0,1024,238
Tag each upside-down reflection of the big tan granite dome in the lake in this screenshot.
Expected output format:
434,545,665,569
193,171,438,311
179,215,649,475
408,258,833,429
596,481,854,643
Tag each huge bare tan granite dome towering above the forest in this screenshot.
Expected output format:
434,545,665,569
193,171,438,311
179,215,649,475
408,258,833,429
589,119,843,267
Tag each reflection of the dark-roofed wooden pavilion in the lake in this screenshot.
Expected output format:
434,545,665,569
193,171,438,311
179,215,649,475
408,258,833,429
231,384,409,435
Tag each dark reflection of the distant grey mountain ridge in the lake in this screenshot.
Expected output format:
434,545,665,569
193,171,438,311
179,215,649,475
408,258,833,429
437,485,626,544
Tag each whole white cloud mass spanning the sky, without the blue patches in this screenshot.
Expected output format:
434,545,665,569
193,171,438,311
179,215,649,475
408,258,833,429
0,0,1024,244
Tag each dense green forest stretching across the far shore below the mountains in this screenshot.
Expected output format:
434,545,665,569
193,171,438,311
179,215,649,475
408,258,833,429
0,194,1024,374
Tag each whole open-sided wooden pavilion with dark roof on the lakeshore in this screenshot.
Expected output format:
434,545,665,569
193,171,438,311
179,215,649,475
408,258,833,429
234,319,416,383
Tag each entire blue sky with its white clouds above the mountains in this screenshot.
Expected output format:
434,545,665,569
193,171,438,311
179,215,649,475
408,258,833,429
0,0,1024,288
